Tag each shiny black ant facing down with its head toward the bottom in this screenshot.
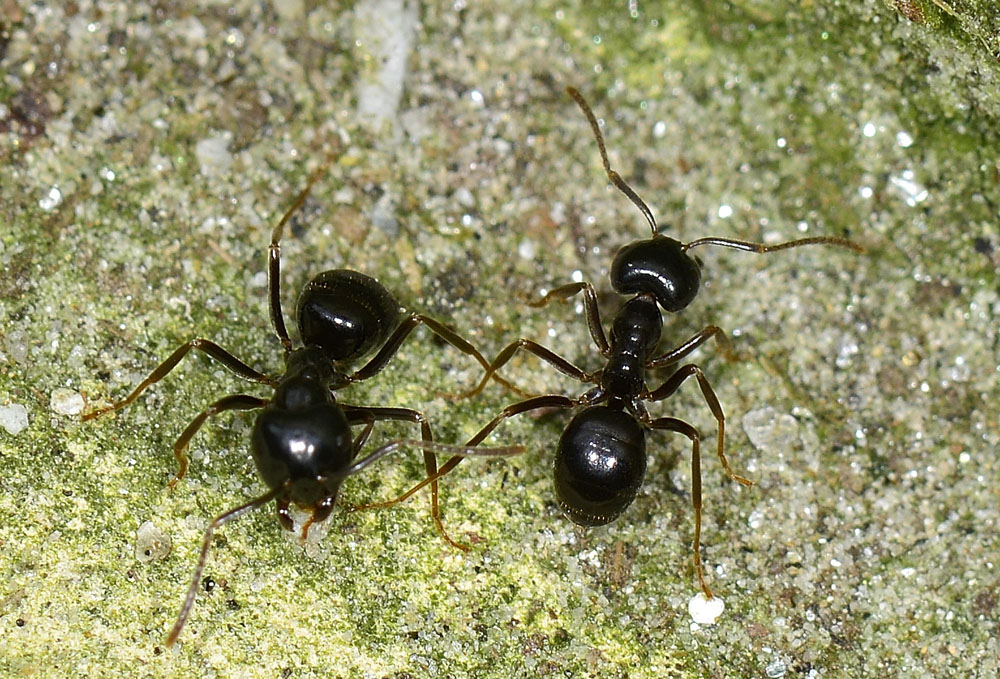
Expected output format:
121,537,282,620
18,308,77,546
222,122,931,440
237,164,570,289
83,157,523,646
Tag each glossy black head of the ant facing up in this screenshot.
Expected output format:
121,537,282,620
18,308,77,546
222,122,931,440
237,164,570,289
609,235,701,313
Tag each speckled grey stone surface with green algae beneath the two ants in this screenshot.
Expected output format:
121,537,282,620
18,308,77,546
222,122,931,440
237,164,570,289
0,0,1000,677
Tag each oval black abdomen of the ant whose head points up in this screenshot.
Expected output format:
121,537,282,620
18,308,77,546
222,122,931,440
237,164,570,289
554,406,646,526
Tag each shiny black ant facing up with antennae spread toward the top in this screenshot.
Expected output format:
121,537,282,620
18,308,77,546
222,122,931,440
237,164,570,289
368,87,864,598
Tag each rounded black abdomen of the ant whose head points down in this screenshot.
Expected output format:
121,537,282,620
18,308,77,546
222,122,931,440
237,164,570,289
296,269,401,362
